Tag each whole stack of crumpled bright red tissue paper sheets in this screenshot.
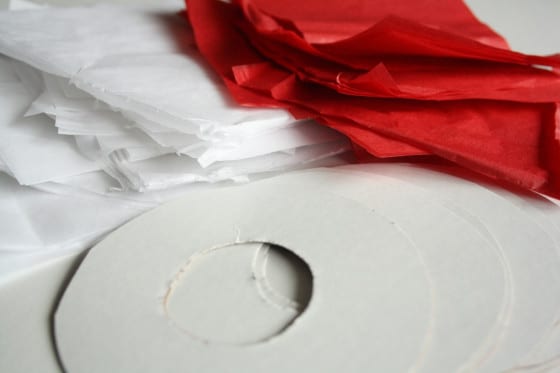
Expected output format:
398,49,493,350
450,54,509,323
186,0,560,195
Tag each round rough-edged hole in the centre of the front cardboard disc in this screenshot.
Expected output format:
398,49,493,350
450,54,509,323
164,242,313,345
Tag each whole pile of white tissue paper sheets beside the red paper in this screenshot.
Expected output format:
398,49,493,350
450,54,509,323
0,3,350,277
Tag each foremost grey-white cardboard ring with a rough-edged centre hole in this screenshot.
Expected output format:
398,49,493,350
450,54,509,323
55,178,431,373
